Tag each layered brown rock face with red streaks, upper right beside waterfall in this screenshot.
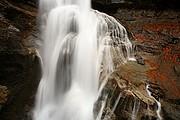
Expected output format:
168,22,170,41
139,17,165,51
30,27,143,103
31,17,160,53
114,9,180,55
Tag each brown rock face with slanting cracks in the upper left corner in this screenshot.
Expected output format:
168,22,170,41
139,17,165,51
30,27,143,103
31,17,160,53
0,0,36,54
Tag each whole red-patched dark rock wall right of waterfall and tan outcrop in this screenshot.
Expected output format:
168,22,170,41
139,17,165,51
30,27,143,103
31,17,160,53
93,1,180,120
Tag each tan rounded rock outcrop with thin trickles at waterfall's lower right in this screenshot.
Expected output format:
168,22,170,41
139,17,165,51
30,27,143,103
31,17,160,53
95,62,163,120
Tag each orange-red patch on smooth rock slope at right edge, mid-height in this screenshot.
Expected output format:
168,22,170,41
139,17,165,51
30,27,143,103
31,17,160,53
146,47,180,97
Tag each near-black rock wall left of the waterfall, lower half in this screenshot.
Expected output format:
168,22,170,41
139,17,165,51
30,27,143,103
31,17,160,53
0,53,40,120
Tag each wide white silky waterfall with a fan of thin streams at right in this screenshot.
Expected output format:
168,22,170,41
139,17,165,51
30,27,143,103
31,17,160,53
34,0,133,120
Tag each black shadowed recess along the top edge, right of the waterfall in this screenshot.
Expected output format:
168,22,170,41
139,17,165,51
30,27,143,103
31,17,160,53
92,0,180,12
